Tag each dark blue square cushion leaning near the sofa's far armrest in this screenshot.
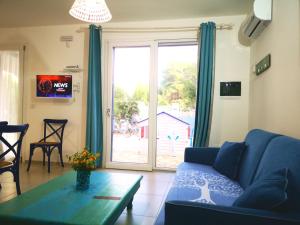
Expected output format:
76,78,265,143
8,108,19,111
213,141,246,180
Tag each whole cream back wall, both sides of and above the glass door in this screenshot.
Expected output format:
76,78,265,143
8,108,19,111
0,16,250,164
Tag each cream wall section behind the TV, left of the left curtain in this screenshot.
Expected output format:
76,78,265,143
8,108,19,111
0,26,86,160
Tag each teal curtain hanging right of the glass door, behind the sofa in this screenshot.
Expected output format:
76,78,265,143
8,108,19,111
193,22,216,147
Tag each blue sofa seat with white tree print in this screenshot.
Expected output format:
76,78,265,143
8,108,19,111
167,163,243,206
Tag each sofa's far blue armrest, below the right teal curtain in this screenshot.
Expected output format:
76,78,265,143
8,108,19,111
184,147,220,165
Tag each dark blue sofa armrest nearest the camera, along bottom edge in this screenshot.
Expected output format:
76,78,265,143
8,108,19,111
165,201,300,225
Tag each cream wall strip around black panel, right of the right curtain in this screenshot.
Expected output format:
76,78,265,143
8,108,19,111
210,16,250,146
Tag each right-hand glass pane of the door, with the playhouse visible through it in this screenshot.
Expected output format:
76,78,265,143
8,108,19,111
155,43,198,169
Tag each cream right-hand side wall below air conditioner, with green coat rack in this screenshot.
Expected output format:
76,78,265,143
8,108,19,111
250,0,300,138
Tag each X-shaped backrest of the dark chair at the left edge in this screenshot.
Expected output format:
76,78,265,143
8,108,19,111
0,124,29,166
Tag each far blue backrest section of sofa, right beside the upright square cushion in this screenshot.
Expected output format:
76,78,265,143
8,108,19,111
238,129,279,189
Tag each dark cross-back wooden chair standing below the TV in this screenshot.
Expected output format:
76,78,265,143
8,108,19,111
27,119,68,173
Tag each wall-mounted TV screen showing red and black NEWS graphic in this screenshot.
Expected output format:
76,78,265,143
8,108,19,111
36,75,72,98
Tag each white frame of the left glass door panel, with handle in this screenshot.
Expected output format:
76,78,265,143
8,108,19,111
104,41,157,171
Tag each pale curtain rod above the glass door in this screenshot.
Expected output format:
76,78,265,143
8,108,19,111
102,24,233,33
